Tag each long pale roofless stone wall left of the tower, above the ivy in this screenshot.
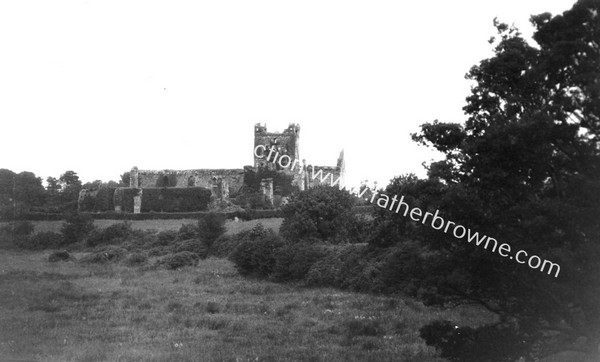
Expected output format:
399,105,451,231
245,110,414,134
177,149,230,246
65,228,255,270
130,167,244,194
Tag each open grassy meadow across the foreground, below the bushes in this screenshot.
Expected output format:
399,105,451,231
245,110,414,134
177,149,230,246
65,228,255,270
0,250,494,361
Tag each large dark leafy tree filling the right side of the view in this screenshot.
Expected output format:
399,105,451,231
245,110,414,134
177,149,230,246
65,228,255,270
378,0,600,360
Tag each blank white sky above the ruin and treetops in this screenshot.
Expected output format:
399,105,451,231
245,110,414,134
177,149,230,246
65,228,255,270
0,0,574,186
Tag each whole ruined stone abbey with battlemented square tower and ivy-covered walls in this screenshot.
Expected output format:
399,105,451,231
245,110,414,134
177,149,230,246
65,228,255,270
79,123,345,213
